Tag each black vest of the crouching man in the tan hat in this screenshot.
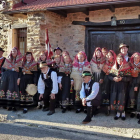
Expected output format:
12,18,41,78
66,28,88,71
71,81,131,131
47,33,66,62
41,70,53,90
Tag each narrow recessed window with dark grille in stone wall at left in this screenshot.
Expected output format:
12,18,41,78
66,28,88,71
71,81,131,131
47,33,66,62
18,28,27,55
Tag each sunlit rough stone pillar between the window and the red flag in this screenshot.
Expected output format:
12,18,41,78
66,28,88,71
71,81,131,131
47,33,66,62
27,13,45,58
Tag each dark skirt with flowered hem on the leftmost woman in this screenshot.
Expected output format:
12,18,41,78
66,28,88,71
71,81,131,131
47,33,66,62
0,70,20,107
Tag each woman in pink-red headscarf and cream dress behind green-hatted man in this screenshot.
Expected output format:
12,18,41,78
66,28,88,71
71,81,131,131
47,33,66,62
71,51,91,113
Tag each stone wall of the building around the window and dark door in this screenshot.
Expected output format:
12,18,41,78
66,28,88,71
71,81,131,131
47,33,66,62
0,4,140,57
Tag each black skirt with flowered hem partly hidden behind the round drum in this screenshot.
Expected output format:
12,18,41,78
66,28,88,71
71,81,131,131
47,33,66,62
20,74,37,107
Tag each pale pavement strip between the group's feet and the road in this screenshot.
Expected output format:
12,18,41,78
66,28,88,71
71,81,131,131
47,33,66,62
0,109,140,140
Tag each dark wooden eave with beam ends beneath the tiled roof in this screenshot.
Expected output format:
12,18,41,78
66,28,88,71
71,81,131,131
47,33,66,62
3,0,140,17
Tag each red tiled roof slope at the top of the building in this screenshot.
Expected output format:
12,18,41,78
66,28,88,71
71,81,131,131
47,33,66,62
10,0,126,11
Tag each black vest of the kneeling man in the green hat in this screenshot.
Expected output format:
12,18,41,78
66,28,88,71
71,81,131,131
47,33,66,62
84,80,101,101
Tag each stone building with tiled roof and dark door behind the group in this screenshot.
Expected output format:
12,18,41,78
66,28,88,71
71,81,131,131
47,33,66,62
0,0,140,59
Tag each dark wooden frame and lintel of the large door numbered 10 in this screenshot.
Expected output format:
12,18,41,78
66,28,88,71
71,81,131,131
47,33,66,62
77,19,140,60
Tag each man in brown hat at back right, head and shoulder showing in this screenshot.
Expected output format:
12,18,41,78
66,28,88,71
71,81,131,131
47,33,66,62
119,43,131,62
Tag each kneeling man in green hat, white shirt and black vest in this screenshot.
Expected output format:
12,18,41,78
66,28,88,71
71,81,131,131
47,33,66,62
80,71,101,124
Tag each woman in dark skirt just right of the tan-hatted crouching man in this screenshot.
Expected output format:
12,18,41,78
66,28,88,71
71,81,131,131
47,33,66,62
59,55,74,113
